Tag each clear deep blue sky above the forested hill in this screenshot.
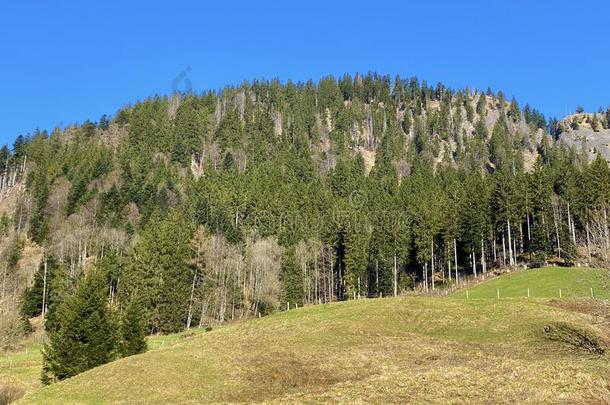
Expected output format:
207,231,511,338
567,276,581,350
0,0,610,144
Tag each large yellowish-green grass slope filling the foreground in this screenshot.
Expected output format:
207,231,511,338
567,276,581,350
20,297,610,404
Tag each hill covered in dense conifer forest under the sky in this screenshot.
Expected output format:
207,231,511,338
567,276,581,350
0,74,610,356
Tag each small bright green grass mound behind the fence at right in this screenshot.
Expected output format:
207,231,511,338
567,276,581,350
452,267,610,299
